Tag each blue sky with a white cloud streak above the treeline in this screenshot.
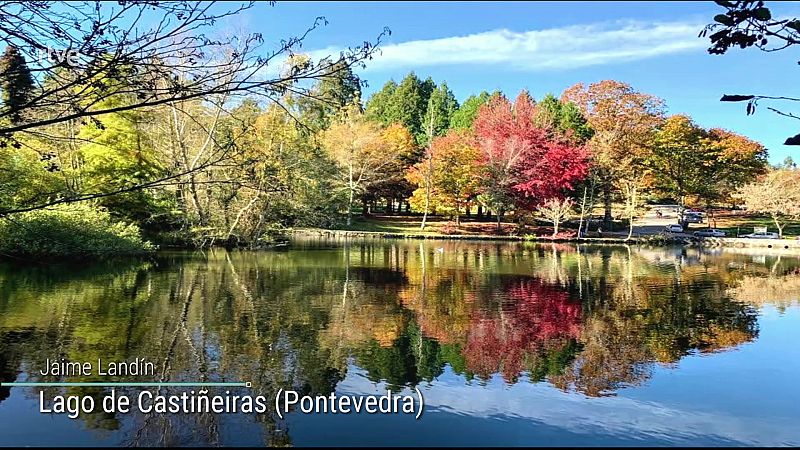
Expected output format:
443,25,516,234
242,1,800,163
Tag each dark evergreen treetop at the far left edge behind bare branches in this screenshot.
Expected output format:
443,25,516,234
0,45,33,124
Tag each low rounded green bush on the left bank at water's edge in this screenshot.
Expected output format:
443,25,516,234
0,203,154,258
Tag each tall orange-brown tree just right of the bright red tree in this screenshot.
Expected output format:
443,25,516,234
561,80,664,228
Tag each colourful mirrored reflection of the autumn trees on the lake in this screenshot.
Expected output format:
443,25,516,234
0,240,800,445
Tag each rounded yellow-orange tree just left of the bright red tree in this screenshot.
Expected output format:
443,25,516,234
408,131,479,225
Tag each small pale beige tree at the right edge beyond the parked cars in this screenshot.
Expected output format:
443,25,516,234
737,169,800,237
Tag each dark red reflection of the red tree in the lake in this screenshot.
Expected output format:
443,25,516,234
464,279,581,382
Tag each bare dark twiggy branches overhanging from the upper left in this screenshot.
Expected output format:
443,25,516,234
0,1,386,218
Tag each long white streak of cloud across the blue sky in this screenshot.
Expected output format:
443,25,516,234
312,21,708,71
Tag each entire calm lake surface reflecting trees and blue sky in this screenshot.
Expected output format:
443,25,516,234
0,240,800,445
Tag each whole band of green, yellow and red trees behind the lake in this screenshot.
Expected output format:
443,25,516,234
0,2,780,247
